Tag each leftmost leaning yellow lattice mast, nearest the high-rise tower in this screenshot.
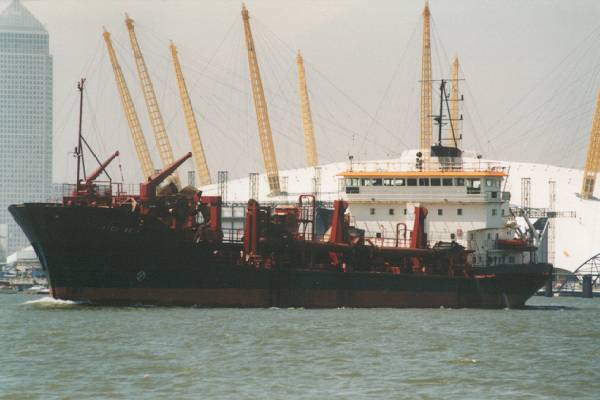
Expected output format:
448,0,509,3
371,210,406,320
103,29,154,179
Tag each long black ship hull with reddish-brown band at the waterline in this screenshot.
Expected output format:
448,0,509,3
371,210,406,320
9,204,552,308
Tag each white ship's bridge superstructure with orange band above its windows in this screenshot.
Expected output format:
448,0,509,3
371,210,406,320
338,157,510,245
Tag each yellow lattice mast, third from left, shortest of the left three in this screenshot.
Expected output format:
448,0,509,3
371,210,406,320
170,42,211,185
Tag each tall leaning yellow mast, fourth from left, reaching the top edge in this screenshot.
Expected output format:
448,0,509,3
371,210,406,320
242,4,281,195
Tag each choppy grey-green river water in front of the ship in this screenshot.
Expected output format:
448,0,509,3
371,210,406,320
0,294,600,399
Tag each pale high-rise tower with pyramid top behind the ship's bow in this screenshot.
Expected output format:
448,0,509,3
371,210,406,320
0,0,52,259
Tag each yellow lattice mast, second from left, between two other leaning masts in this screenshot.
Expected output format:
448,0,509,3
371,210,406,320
125,14,181,188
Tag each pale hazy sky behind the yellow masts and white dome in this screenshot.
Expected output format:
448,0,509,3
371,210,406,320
8,0,600,181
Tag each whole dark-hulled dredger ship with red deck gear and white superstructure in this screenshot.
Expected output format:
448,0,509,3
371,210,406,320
9,79,552,308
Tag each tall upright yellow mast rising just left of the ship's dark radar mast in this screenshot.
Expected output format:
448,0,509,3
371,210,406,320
420,2,433,154
